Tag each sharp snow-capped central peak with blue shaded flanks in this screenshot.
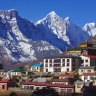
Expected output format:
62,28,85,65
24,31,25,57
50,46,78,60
36,11,89,51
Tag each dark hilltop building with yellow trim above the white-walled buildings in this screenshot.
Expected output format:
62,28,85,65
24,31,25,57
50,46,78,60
67,42,96,56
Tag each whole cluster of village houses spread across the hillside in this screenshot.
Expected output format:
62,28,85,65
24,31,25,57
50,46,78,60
0,42,96,93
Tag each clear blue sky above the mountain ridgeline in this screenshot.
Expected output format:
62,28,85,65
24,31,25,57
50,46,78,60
0,0,96,27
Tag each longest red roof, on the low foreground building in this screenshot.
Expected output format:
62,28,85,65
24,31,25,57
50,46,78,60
23,82,74,88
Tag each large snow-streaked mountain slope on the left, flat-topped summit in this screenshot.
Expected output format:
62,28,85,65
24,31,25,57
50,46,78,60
0,10,61,61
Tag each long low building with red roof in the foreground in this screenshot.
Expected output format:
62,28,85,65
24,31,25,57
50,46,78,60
22,82,75,93
